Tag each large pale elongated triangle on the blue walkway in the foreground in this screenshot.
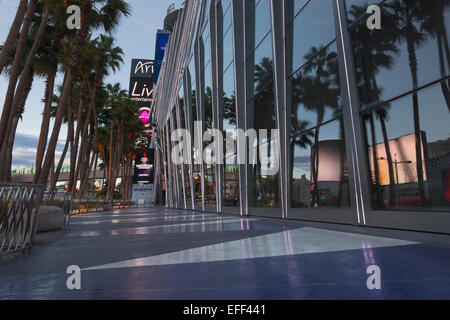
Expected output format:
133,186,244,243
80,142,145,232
85,227,415,270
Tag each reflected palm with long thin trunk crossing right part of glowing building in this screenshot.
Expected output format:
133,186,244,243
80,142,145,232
387,0,426,204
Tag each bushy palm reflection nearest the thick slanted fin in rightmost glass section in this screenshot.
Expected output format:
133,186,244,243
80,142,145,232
349,5,399,207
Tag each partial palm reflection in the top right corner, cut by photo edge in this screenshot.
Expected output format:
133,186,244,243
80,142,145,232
417,0,450,111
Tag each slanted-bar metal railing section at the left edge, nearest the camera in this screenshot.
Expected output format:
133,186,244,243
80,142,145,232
0,182,44,255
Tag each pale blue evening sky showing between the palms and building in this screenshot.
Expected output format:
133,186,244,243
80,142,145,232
0,0,183,167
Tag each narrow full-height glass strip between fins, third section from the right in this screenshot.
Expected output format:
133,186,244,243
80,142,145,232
246,0,281,216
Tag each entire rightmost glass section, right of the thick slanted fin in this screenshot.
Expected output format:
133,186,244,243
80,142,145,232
347,0,450,211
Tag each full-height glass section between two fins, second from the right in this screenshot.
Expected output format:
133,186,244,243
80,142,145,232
287,0,350,211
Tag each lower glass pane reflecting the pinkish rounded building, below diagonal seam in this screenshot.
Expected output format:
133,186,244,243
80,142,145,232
289,118,350,209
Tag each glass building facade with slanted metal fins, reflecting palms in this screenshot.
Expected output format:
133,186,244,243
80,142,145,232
152,0,450,233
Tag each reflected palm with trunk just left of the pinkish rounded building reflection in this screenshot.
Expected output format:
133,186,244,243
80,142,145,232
294,46,340,206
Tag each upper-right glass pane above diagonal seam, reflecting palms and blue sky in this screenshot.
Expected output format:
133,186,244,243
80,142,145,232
348,0,450,108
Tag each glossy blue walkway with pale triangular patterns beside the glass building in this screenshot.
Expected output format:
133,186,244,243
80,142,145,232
0,208,450,300
